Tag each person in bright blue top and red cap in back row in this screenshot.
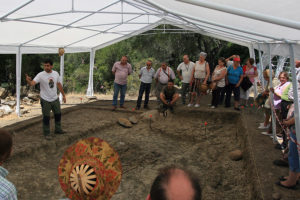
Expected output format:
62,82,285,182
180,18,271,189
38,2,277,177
225,57,244,110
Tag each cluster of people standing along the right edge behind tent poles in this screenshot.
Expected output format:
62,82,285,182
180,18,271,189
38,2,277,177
256,61,300,189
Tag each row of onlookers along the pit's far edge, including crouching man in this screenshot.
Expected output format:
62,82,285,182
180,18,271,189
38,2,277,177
112,52,258,111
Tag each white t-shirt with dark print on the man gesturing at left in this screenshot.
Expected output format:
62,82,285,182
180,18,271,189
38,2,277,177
33,70,61,102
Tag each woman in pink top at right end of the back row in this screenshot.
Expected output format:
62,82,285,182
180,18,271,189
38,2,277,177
240,58,258,106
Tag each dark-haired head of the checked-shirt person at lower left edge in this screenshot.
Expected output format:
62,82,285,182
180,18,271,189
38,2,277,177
0,129,13,162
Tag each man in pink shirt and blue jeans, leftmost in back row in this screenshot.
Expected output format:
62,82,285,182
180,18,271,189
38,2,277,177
112,56,132,110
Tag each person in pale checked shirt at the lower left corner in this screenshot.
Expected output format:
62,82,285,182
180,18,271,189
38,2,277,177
0,129,18,200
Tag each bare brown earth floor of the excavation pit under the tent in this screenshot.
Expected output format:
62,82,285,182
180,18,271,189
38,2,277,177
4,97,300,200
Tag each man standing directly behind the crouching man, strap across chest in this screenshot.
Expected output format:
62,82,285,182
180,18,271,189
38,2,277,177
154,62,175,101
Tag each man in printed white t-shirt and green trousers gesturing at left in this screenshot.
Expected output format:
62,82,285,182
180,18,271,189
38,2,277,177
26,59,66,140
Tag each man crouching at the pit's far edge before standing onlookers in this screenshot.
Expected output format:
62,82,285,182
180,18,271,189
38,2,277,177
160,80,179,113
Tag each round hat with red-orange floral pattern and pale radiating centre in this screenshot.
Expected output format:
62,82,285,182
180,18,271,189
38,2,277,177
58,137,122,200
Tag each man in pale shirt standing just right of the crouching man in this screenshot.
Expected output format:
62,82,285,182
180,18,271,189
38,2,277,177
177,55,195,105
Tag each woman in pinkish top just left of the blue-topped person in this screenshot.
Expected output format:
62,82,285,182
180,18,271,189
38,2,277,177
211,57,227,109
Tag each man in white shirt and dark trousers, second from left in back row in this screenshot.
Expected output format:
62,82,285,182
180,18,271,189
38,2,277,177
136,60,155,110
